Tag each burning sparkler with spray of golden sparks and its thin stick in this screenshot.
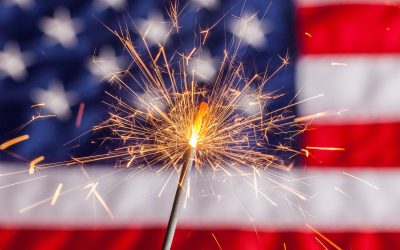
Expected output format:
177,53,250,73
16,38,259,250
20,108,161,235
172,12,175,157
15,4,328,249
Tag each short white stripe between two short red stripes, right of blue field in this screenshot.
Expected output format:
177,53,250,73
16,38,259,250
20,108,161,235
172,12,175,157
296,55,400,123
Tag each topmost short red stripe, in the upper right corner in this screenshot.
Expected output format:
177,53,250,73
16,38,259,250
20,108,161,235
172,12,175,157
297,4,400,54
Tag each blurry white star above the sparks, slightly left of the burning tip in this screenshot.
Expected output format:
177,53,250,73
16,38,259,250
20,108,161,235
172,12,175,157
137,13,172,45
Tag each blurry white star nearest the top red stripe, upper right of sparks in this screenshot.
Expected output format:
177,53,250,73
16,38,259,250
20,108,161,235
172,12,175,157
229,13,271,49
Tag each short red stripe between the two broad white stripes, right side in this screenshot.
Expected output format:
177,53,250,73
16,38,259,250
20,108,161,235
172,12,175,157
302,123,400,167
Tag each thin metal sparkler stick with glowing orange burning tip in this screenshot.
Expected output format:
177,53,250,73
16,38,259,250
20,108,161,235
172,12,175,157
162,102,208,250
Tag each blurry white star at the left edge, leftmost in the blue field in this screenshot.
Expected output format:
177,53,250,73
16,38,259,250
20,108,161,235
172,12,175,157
0,42,33,81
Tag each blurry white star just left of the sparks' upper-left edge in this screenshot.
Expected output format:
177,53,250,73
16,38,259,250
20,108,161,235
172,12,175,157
88,47,126,80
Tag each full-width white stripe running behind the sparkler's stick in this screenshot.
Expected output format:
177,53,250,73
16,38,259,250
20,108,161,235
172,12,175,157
0,166,400,230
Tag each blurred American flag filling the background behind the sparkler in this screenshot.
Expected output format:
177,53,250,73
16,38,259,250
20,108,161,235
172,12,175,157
0,0,400,249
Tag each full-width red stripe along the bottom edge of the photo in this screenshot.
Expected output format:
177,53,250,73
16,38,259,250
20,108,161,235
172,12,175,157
0,229,400,250
